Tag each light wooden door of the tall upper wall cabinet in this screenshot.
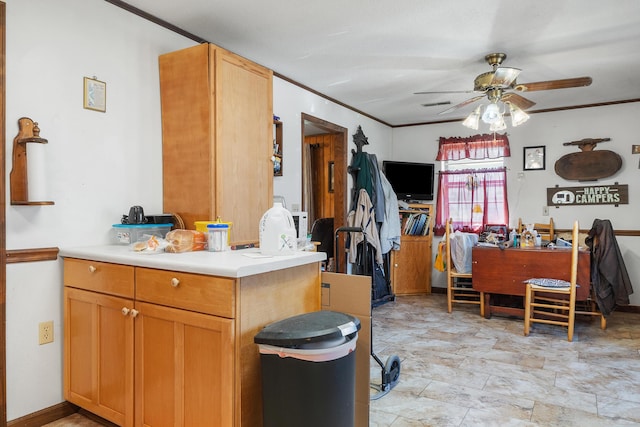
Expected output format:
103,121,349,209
212,48,273,243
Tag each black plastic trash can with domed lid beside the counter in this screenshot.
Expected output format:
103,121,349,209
254,311,360,427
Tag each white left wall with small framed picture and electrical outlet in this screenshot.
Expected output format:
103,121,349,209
5,0,195,420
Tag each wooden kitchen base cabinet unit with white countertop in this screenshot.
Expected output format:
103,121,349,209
60,245,325,427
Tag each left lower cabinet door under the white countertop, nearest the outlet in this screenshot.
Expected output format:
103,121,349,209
64,287,133,427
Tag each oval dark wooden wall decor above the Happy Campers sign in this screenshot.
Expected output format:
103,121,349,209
554,138,622,181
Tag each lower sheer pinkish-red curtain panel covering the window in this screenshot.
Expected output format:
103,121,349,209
434,168,509,236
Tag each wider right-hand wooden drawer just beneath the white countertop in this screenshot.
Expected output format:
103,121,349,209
136,267,235,318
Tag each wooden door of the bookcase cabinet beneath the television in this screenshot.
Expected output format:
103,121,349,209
391,236,431,295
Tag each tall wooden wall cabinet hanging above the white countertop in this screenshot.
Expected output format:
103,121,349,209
159,44,273,243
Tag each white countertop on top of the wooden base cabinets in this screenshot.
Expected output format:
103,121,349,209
59,245,326,278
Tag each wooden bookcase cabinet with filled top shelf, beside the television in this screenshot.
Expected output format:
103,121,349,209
391,203,434,295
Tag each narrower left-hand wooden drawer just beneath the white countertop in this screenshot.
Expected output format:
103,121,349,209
64,258,135,298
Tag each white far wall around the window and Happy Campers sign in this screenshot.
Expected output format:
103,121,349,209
391,103,640,305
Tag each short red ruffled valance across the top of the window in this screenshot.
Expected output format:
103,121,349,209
436,133,511,160
